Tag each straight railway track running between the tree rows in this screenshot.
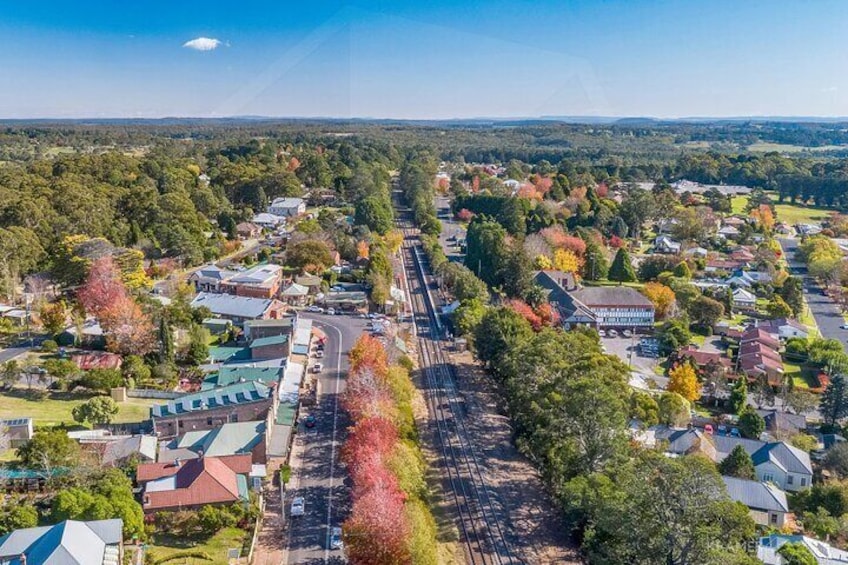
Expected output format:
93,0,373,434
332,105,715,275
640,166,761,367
398,214,521,565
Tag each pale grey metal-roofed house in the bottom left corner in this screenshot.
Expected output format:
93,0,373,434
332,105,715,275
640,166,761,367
0,518,124,565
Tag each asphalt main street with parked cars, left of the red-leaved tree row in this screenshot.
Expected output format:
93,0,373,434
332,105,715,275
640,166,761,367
283,312,367,564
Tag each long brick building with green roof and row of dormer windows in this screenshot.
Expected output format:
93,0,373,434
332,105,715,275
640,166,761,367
150,381,277,438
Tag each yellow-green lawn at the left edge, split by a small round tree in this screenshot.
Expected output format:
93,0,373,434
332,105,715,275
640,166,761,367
0,388,157,426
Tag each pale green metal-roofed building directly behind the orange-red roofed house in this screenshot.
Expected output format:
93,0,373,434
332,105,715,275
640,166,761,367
158,420,268,465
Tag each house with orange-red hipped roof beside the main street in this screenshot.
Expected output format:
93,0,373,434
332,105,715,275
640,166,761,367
136,453,252,513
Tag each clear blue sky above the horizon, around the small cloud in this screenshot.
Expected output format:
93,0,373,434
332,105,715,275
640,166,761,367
0,0,848,118
